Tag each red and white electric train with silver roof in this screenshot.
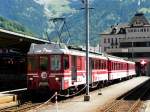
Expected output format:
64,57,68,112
27,44,136,91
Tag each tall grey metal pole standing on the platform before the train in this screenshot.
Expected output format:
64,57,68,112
84,0,90,101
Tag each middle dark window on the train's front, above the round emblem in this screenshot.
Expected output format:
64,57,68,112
40,56,48,71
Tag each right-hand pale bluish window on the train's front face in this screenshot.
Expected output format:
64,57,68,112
51,55,61,70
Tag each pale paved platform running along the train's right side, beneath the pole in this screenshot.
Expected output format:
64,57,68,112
29,76,149,112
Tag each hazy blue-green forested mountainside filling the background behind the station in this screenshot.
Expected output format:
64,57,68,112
0,0,150,46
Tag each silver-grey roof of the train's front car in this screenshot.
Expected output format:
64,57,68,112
28,43,107,59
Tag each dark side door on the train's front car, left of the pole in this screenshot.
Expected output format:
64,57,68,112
71,56,77,80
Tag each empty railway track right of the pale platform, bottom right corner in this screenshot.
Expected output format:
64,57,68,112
98,80,150,112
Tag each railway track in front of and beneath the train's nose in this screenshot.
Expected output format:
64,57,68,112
0,91,54,112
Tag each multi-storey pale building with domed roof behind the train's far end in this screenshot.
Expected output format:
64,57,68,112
100,13,150,75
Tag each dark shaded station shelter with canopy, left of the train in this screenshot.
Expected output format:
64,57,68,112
0,29,48,90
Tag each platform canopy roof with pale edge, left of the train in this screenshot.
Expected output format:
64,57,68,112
0,29,49,53
